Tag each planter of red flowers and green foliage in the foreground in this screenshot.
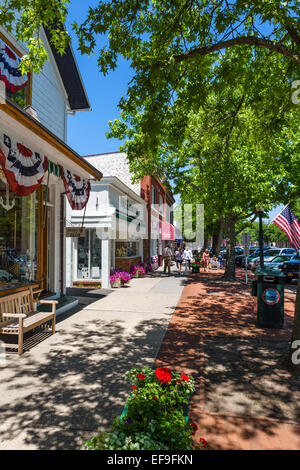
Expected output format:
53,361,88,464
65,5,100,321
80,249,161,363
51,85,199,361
85,367,206,450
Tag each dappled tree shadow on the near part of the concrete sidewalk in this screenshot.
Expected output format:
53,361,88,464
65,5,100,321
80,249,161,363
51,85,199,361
0,312,171,450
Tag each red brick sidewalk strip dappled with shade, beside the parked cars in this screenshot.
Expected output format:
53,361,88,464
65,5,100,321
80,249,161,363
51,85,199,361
156,272,300,450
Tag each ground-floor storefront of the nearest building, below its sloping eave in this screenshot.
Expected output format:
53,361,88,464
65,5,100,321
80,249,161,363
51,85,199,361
0,101,101,296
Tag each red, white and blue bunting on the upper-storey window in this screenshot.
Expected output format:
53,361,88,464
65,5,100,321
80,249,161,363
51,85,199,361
0,40,28,93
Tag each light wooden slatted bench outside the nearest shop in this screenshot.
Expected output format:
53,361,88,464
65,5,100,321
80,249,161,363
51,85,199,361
0,287,58,356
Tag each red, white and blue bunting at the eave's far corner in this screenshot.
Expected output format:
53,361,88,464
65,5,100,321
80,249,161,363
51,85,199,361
60,166,91,211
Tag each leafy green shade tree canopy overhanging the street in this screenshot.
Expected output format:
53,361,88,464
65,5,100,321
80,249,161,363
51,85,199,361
0,0,300,368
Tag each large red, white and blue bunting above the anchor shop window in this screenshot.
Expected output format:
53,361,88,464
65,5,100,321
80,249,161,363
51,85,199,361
0,135,48,196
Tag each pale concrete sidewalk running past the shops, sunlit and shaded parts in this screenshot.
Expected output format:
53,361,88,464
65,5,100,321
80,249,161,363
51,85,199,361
0,273,186,450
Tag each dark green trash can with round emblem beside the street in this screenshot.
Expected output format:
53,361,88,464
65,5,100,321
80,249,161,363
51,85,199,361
255,267,285,328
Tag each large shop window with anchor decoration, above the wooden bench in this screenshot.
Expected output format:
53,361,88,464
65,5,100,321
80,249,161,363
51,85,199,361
0,172,38,290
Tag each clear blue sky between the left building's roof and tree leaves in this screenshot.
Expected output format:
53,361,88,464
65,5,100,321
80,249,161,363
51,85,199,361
67,0,132,155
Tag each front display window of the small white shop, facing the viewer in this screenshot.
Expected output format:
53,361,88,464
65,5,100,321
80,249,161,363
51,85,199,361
77,230,101,279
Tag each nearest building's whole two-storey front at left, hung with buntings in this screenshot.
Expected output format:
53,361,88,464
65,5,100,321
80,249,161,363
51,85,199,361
0,25,101,297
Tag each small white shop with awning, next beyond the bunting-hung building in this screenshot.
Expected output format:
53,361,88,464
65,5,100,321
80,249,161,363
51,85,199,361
67,177,147,289
